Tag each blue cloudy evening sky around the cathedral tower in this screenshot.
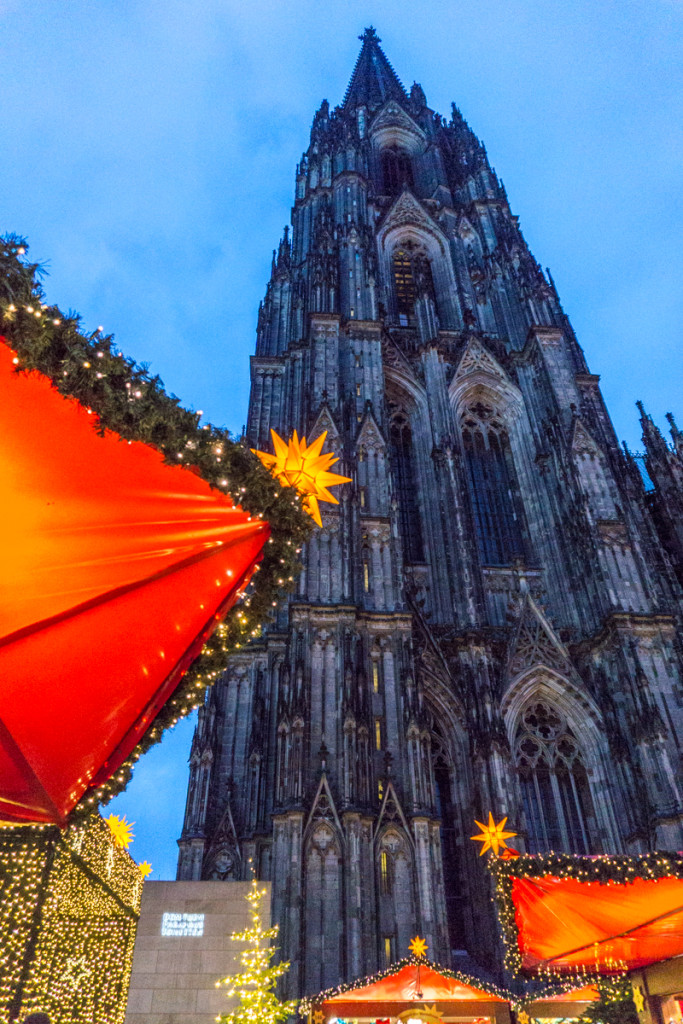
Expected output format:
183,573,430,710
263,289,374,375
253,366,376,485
0,0,683,879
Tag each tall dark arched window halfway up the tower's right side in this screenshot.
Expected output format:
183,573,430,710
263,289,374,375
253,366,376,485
461,402,524,565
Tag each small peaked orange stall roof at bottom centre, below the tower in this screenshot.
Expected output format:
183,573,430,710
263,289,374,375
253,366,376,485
301,958,512,1021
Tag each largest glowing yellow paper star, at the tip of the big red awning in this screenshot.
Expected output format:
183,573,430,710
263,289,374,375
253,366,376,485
252,430,351,526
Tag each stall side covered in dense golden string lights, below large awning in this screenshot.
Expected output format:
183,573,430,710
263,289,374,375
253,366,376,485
0,815,143,1024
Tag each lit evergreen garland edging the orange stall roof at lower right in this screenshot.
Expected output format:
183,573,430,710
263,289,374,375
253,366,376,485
490,852,683,974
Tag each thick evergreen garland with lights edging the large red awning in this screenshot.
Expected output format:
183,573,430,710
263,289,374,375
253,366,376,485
0,236,312,814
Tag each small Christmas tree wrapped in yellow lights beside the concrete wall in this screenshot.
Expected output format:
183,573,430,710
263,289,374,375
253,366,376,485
216,879,297,1024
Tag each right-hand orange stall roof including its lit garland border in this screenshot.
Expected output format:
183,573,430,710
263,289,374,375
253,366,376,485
494,853,683,974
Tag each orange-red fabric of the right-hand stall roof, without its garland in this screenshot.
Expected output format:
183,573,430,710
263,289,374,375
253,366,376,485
512,876,683,971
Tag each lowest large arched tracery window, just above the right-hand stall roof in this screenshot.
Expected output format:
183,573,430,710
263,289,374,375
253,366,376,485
515,700,596,853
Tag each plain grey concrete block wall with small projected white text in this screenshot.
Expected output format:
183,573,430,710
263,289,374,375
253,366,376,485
125,882,270,1024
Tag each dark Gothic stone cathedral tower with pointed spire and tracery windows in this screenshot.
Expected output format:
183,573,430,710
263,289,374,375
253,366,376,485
178,29,683,994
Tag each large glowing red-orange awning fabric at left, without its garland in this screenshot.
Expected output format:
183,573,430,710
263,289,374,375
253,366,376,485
0,343,269,823
